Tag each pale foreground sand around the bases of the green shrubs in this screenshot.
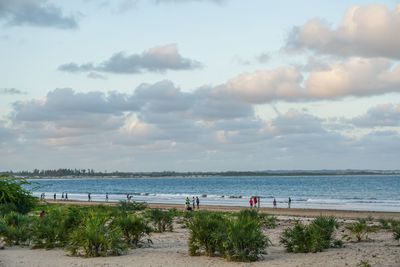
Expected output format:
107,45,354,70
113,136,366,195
0,217,400,267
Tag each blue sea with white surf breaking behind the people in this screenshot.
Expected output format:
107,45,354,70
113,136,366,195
28,175,400,212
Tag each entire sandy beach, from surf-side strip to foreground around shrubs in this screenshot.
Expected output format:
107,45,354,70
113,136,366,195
0,201,400,267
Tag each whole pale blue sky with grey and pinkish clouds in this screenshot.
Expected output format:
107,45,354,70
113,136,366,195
0,0,400,171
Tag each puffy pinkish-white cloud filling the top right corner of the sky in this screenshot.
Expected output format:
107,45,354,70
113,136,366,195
286,4,400,59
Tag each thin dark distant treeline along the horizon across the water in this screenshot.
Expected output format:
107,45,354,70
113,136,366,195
0,169,400,177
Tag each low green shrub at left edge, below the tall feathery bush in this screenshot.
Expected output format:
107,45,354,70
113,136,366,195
0,212,32,245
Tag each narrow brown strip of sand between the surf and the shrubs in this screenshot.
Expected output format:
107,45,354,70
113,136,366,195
41,200,400,219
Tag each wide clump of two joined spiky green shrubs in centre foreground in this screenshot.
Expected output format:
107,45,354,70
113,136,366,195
188,210,269,262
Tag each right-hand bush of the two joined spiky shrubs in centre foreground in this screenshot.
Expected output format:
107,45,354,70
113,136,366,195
223,216,270,262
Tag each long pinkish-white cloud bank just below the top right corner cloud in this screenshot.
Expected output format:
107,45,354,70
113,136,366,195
221,58,400,104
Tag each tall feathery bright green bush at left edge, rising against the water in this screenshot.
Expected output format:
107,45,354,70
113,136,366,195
0,175,37,214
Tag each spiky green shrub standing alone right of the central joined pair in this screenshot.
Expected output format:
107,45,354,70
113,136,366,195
280,216,338,253
